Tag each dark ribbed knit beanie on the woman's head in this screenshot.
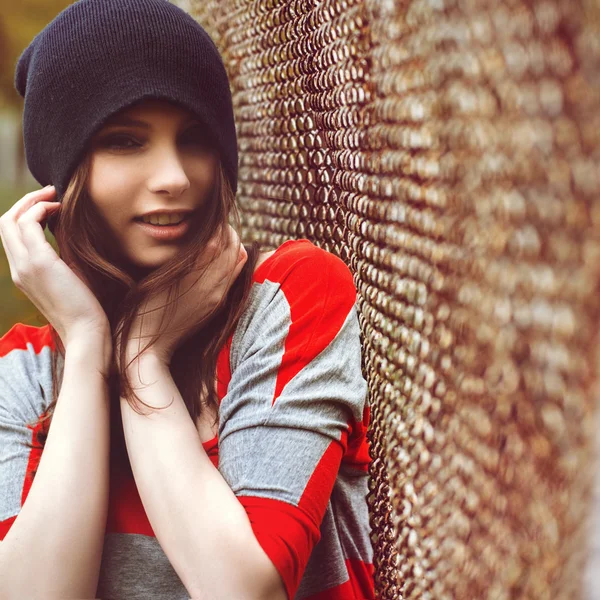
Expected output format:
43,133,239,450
15,0,237,201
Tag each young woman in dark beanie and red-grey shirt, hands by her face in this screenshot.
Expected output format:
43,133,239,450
0,0,373,600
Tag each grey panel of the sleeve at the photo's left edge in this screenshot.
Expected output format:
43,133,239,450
0,344,52,521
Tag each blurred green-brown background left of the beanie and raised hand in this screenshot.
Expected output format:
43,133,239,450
0,0,71,336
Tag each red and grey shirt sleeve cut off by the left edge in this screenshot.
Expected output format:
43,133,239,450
0,323,52,540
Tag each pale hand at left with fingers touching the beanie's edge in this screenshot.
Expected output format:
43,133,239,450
0,186,110,348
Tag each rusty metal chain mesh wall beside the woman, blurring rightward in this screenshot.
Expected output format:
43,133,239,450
171,0,600,600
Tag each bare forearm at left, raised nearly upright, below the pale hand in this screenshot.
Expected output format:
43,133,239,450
0,338,110,600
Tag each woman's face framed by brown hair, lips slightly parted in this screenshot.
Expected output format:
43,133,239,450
88,99,217,272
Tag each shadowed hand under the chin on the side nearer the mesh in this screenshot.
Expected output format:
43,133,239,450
117,225,248,364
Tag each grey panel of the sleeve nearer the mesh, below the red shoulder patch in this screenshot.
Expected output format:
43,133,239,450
219,281,366,505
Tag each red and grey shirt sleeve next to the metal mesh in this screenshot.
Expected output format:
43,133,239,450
219,246,367,599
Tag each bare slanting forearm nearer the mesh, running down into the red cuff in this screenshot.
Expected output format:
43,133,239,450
121,354,286,600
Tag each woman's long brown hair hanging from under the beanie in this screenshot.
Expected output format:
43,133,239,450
27,154,259,468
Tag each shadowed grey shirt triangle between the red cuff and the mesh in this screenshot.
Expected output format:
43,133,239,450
295,503,349,600
